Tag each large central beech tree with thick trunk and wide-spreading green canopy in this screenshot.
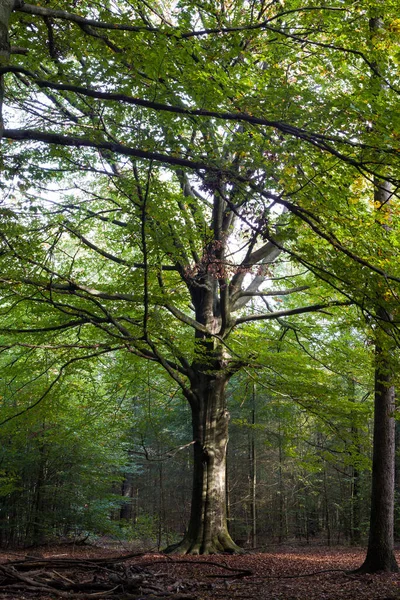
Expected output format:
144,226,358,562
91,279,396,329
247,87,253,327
0,0,400,553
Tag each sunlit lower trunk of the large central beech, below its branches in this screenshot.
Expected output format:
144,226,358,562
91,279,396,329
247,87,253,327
166,373,240,554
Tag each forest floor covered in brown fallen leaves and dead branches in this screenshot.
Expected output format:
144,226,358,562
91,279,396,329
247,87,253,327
0,545,400,600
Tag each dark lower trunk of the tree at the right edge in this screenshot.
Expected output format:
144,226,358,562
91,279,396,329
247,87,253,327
359,332,399,573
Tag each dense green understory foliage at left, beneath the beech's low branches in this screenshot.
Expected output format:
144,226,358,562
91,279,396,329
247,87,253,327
0,354,133,544
